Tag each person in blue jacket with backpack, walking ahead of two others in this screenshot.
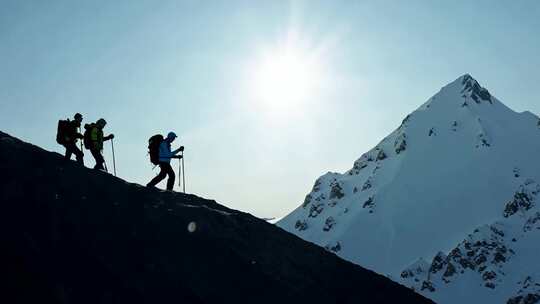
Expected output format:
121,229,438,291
146,132,184,191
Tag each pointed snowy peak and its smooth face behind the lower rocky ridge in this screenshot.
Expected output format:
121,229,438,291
278,75,540,279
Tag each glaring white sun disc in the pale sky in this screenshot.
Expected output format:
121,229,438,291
250,40,321,112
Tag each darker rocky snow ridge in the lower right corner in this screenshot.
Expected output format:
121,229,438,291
401,179,540,304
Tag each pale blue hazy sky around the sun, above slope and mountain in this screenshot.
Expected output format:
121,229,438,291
0,0,540,217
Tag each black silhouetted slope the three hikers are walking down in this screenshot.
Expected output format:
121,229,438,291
0,132,432,303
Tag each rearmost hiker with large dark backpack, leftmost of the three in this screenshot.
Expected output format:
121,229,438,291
56,113,84,165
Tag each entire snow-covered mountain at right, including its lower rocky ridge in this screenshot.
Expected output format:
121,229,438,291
277,75,540,303
